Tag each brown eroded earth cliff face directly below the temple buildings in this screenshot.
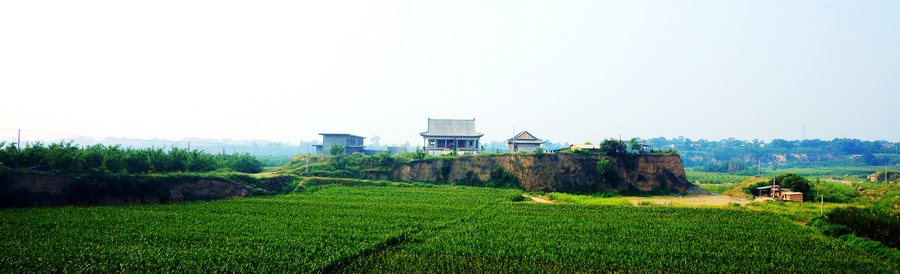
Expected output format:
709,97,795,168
365,154,690,192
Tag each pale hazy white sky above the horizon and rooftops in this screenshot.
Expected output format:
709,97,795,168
0,0,900,145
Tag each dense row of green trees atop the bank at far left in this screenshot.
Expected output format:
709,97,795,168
0,141,263,174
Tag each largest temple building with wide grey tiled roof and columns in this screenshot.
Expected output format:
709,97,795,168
420,118,484,154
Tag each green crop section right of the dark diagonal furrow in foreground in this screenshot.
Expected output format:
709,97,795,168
341,203,897,273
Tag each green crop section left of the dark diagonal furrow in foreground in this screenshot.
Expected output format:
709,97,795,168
0,187,514,273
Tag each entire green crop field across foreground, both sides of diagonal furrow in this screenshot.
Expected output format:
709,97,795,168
0,186,898,273
